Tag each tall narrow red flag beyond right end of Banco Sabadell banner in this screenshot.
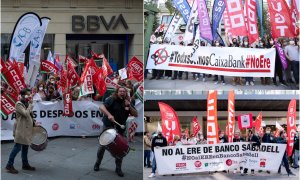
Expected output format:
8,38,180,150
286,99,297,157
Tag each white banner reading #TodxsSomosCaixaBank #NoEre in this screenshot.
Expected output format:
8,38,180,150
147,44,275,77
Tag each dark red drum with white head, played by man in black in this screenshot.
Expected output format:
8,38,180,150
99,128,130,159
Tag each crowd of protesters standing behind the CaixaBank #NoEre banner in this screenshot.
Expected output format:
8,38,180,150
149,36,300,89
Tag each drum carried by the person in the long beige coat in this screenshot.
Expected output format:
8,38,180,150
30,126,48,151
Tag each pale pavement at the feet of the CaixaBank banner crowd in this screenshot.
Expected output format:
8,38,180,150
144,73,297,90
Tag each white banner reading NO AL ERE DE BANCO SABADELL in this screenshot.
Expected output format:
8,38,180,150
154,142,286,175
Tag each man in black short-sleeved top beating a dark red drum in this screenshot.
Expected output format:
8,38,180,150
94,87,138,177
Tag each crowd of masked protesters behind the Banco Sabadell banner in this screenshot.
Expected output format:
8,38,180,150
144,127,299,178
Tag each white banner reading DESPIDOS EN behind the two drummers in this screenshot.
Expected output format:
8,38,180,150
1,100,144,140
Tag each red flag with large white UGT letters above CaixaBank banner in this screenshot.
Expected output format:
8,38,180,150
268,0,295,38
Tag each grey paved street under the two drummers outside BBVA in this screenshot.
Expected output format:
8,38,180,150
1,137,143,180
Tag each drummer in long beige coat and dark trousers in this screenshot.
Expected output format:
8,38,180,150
6,89,35,174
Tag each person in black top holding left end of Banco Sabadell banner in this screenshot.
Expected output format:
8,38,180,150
148,132,168,178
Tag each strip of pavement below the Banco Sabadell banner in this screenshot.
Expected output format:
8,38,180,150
144,167,299,180
